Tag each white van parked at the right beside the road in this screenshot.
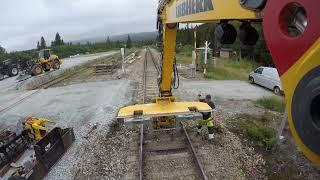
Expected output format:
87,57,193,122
249,67,283,95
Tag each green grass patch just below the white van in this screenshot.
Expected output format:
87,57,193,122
255,96,286,112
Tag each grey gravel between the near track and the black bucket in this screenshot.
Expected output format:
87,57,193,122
75,126,133,179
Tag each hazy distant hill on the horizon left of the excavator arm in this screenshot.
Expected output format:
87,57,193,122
72,32,158,43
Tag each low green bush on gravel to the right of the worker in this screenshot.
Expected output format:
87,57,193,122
246,127,276,149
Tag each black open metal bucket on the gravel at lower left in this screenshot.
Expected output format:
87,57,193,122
26,128,75,180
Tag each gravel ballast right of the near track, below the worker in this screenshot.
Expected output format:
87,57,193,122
182,122,267,179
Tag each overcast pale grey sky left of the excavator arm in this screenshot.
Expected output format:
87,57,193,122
0,0,158,51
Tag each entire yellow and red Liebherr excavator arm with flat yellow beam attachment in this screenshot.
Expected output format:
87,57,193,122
118,0,320,164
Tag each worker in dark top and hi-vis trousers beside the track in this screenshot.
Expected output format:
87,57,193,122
197,94,216,139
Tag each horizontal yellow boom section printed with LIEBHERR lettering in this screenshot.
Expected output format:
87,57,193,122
160,0,262,24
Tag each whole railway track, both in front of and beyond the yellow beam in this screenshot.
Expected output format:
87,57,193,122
129,48,207,180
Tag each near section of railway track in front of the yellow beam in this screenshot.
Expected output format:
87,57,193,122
139,124,208,180
